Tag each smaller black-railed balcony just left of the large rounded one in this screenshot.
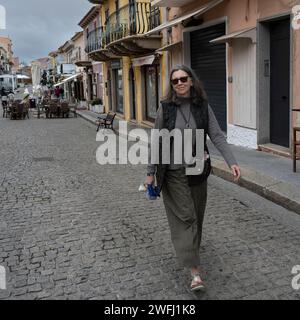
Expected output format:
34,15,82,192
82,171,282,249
85,27,116,61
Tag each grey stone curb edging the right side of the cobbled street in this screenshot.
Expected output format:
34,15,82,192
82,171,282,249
77,113,300,214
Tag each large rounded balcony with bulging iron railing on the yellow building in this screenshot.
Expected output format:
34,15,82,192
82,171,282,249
104,1,161,56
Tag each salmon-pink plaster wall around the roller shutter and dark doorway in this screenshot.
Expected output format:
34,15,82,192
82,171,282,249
169,0,300,127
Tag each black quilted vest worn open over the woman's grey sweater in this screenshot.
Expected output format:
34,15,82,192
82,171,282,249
156,101,208,190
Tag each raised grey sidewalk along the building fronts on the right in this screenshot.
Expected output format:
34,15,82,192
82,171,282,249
77,111,300,214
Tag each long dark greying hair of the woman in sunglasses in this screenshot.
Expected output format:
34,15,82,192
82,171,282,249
163,65,207,105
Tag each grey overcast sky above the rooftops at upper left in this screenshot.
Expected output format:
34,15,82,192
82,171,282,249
0,0,92,63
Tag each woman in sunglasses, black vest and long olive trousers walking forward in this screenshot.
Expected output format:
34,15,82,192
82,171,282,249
147,66,241,291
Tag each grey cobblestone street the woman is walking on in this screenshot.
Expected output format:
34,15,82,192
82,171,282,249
0,118,300,300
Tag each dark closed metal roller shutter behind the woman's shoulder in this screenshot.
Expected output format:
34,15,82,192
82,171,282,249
190,23,227,132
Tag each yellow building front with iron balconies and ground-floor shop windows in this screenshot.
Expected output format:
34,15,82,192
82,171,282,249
88,0,165,126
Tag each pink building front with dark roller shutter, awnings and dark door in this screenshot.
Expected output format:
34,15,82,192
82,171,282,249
152,0,300,154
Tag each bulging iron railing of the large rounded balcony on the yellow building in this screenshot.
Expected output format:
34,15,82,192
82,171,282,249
105,1,160,45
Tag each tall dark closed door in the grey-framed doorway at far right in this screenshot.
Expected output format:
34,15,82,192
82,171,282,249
270,19,290,148
